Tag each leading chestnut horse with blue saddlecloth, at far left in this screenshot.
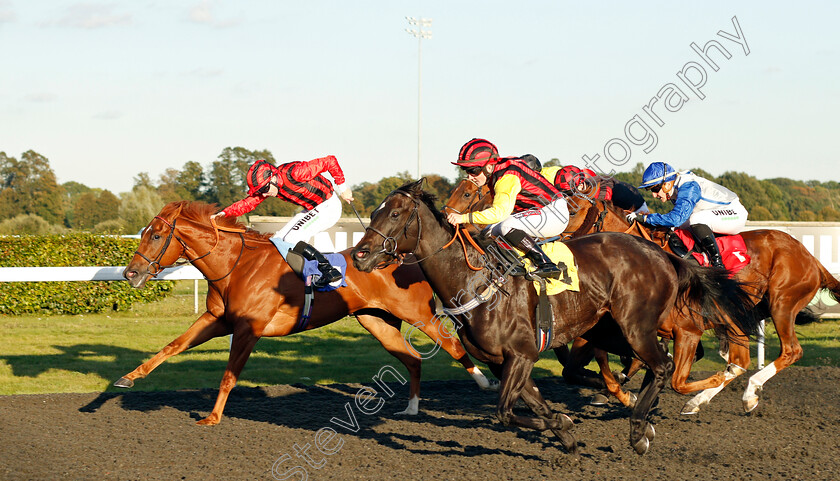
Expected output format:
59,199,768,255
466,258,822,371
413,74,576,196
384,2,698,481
121,201,492,425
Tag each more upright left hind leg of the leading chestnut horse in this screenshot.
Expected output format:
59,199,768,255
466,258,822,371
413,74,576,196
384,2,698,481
356,314,420,415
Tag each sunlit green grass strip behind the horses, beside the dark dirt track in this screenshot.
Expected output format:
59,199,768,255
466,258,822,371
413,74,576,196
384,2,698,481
0,281,840,395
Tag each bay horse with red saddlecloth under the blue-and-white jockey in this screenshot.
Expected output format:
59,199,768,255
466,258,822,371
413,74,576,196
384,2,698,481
568,201,840,414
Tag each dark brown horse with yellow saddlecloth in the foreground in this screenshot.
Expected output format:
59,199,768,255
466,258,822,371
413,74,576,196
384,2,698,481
352,179,754,455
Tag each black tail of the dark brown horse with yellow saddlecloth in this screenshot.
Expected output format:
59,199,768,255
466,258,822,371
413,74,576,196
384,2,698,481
668,254,761,342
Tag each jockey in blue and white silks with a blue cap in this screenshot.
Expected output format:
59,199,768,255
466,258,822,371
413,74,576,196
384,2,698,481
628,162,748,267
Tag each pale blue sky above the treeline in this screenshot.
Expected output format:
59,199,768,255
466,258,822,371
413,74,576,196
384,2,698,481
0,0,840,192
